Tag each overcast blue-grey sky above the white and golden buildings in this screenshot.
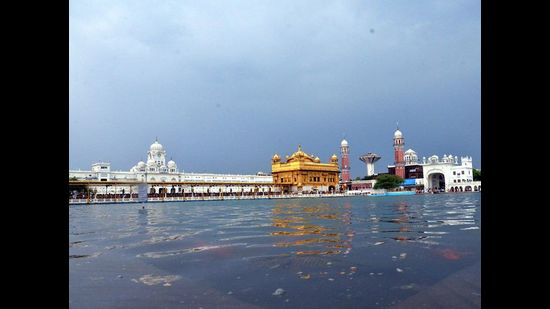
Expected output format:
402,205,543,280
69,0,481,178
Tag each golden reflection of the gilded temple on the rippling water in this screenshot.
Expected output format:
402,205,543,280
270,203,354,255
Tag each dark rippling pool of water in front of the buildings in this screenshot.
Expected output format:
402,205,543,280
69,193,481,309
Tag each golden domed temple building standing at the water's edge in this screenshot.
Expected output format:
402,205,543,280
271,146,340,193
